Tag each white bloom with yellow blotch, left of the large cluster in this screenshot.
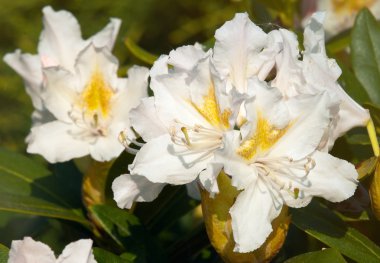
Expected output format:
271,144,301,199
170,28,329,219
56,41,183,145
5,7,148,162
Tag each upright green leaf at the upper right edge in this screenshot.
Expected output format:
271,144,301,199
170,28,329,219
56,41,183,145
351,9,380,104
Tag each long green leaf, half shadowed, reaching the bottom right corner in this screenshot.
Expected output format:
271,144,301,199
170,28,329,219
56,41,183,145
292,202,380,263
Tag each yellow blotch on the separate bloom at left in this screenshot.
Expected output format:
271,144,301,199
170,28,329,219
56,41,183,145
82,70,114,117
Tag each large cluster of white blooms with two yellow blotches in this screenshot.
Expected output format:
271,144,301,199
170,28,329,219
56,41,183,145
112,13,369,252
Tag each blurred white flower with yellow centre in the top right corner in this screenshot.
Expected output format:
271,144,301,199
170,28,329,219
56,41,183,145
316,0,380,36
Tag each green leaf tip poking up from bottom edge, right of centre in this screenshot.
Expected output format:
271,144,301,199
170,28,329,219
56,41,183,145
285,248,346,263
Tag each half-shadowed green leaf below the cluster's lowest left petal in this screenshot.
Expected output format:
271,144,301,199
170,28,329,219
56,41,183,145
90,205,164,262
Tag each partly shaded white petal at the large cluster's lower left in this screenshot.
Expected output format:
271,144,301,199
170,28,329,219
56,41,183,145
112,174,166,209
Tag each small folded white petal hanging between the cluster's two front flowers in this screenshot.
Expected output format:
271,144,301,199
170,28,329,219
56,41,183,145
199,163,223,197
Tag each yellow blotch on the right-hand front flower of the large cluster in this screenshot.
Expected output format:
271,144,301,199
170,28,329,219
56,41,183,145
237,114,289,160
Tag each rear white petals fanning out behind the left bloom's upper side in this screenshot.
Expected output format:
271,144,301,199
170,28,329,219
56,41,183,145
4,6,121,124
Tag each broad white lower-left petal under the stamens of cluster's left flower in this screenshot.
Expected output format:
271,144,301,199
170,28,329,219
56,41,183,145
129,134,210,185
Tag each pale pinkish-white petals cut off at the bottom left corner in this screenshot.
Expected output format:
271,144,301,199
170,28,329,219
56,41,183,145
8,237,96,263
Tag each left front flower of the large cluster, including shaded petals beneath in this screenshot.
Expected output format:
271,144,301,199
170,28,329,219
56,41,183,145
113,45,243,208
